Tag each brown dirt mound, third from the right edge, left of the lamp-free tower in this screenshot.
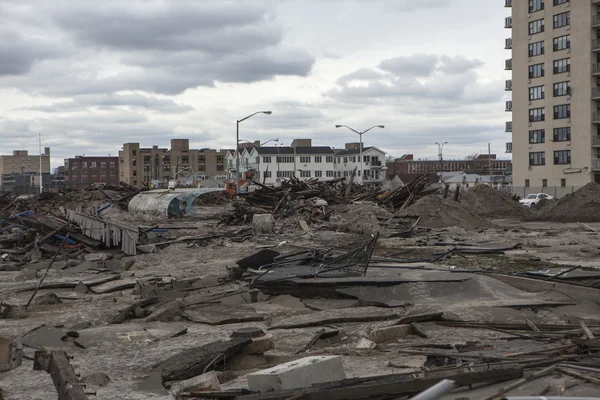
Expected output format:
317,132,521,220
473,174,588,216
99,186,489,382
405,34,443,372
401,195,489,229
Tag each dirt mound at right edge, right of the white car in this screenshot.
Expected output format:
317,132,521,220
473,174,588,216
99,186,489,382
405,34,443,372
536,182,600,222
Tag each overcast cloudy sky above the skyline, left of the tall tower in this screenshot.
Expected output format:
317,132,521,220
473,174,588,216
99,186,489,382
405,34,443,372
0,0,510,167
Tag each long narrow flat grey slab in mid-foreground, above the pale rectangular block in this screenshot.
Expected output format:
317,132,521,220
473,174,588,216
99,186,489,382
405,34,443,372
269,307,398,329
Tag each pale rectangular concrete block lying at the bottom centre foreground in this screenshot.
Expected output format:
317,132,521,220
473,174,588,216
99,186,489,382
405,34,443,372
247,356,346,393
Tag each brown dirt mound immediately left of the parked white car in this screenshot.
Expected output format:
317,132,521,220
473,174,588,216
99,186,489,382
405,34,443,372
461,185,533,218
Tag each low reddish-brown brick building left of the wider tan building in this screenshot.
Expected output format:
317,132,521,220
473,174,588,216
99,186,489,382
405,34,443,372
64,156,120,187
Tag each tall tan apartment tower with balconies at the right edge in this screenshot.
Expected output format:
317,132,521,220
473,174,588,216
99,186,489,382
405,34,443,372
505,0,600,193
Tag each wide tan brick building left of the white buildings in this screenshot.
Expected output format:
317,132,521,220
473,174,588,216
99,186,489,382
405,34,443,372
119,139,227,186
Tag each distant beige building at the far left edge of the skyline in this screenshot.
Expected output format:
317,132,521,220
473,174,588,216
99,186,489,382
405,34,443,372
0,147,50,193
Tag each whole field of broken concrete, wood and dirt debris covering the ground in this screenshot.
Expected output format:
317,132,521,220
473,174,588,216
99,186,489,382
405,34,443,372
0,177,600,400
